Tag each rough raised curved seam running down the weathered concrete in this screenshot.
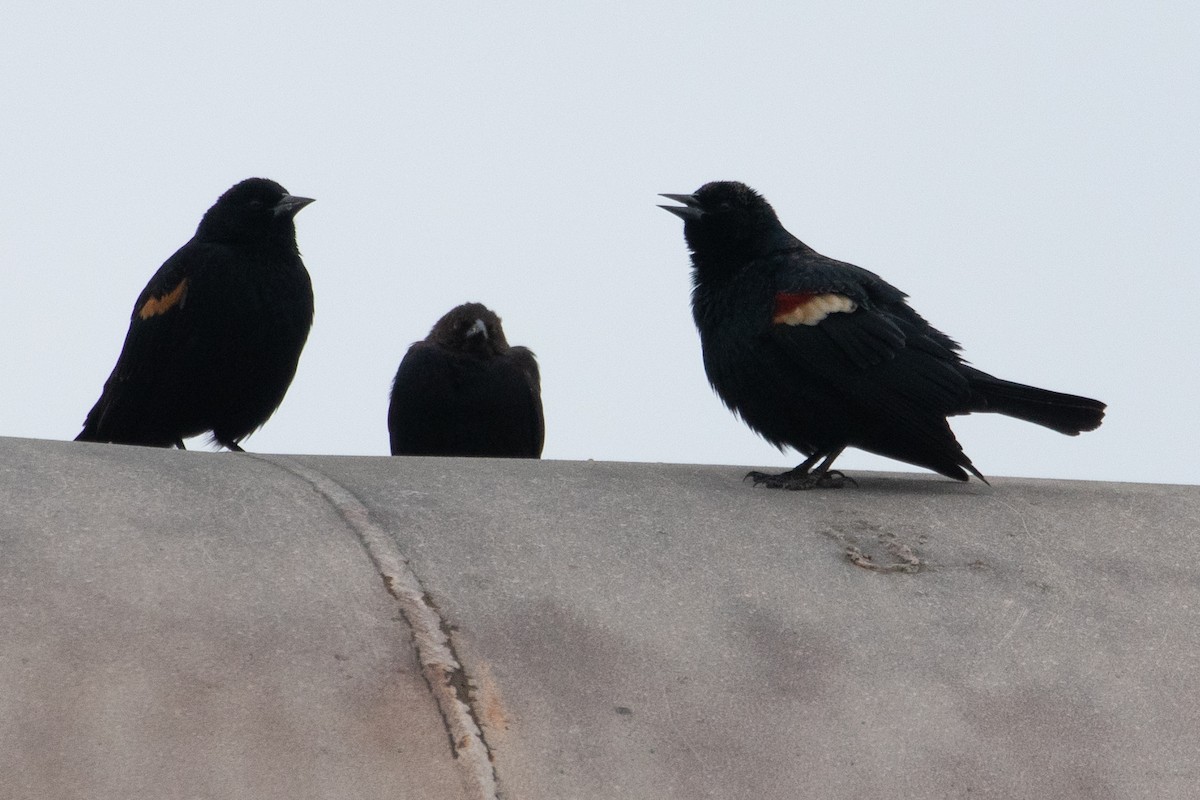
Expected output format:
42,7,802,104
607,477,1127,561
258,453,502,800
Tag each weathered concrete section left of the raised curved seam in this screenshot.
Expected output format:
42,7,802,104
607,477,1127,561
0,439,468,800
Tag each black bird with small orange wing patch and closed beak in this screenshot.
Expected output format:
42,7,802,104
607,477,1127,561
76,178,313,451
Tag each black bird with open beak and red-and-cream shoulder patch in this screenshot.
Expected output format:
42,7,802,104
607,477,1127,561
660,181,1104,489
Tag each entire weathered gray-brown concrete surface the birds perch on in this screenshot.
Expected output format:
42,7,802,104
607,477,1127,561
0,439,1200,800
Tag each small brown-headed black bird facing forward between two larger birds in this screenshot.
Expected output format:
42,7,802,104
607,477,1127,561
388,302,545,458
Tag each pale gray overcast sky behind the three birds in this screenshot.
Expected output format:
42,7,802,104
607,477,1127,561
0,0,1200,483
